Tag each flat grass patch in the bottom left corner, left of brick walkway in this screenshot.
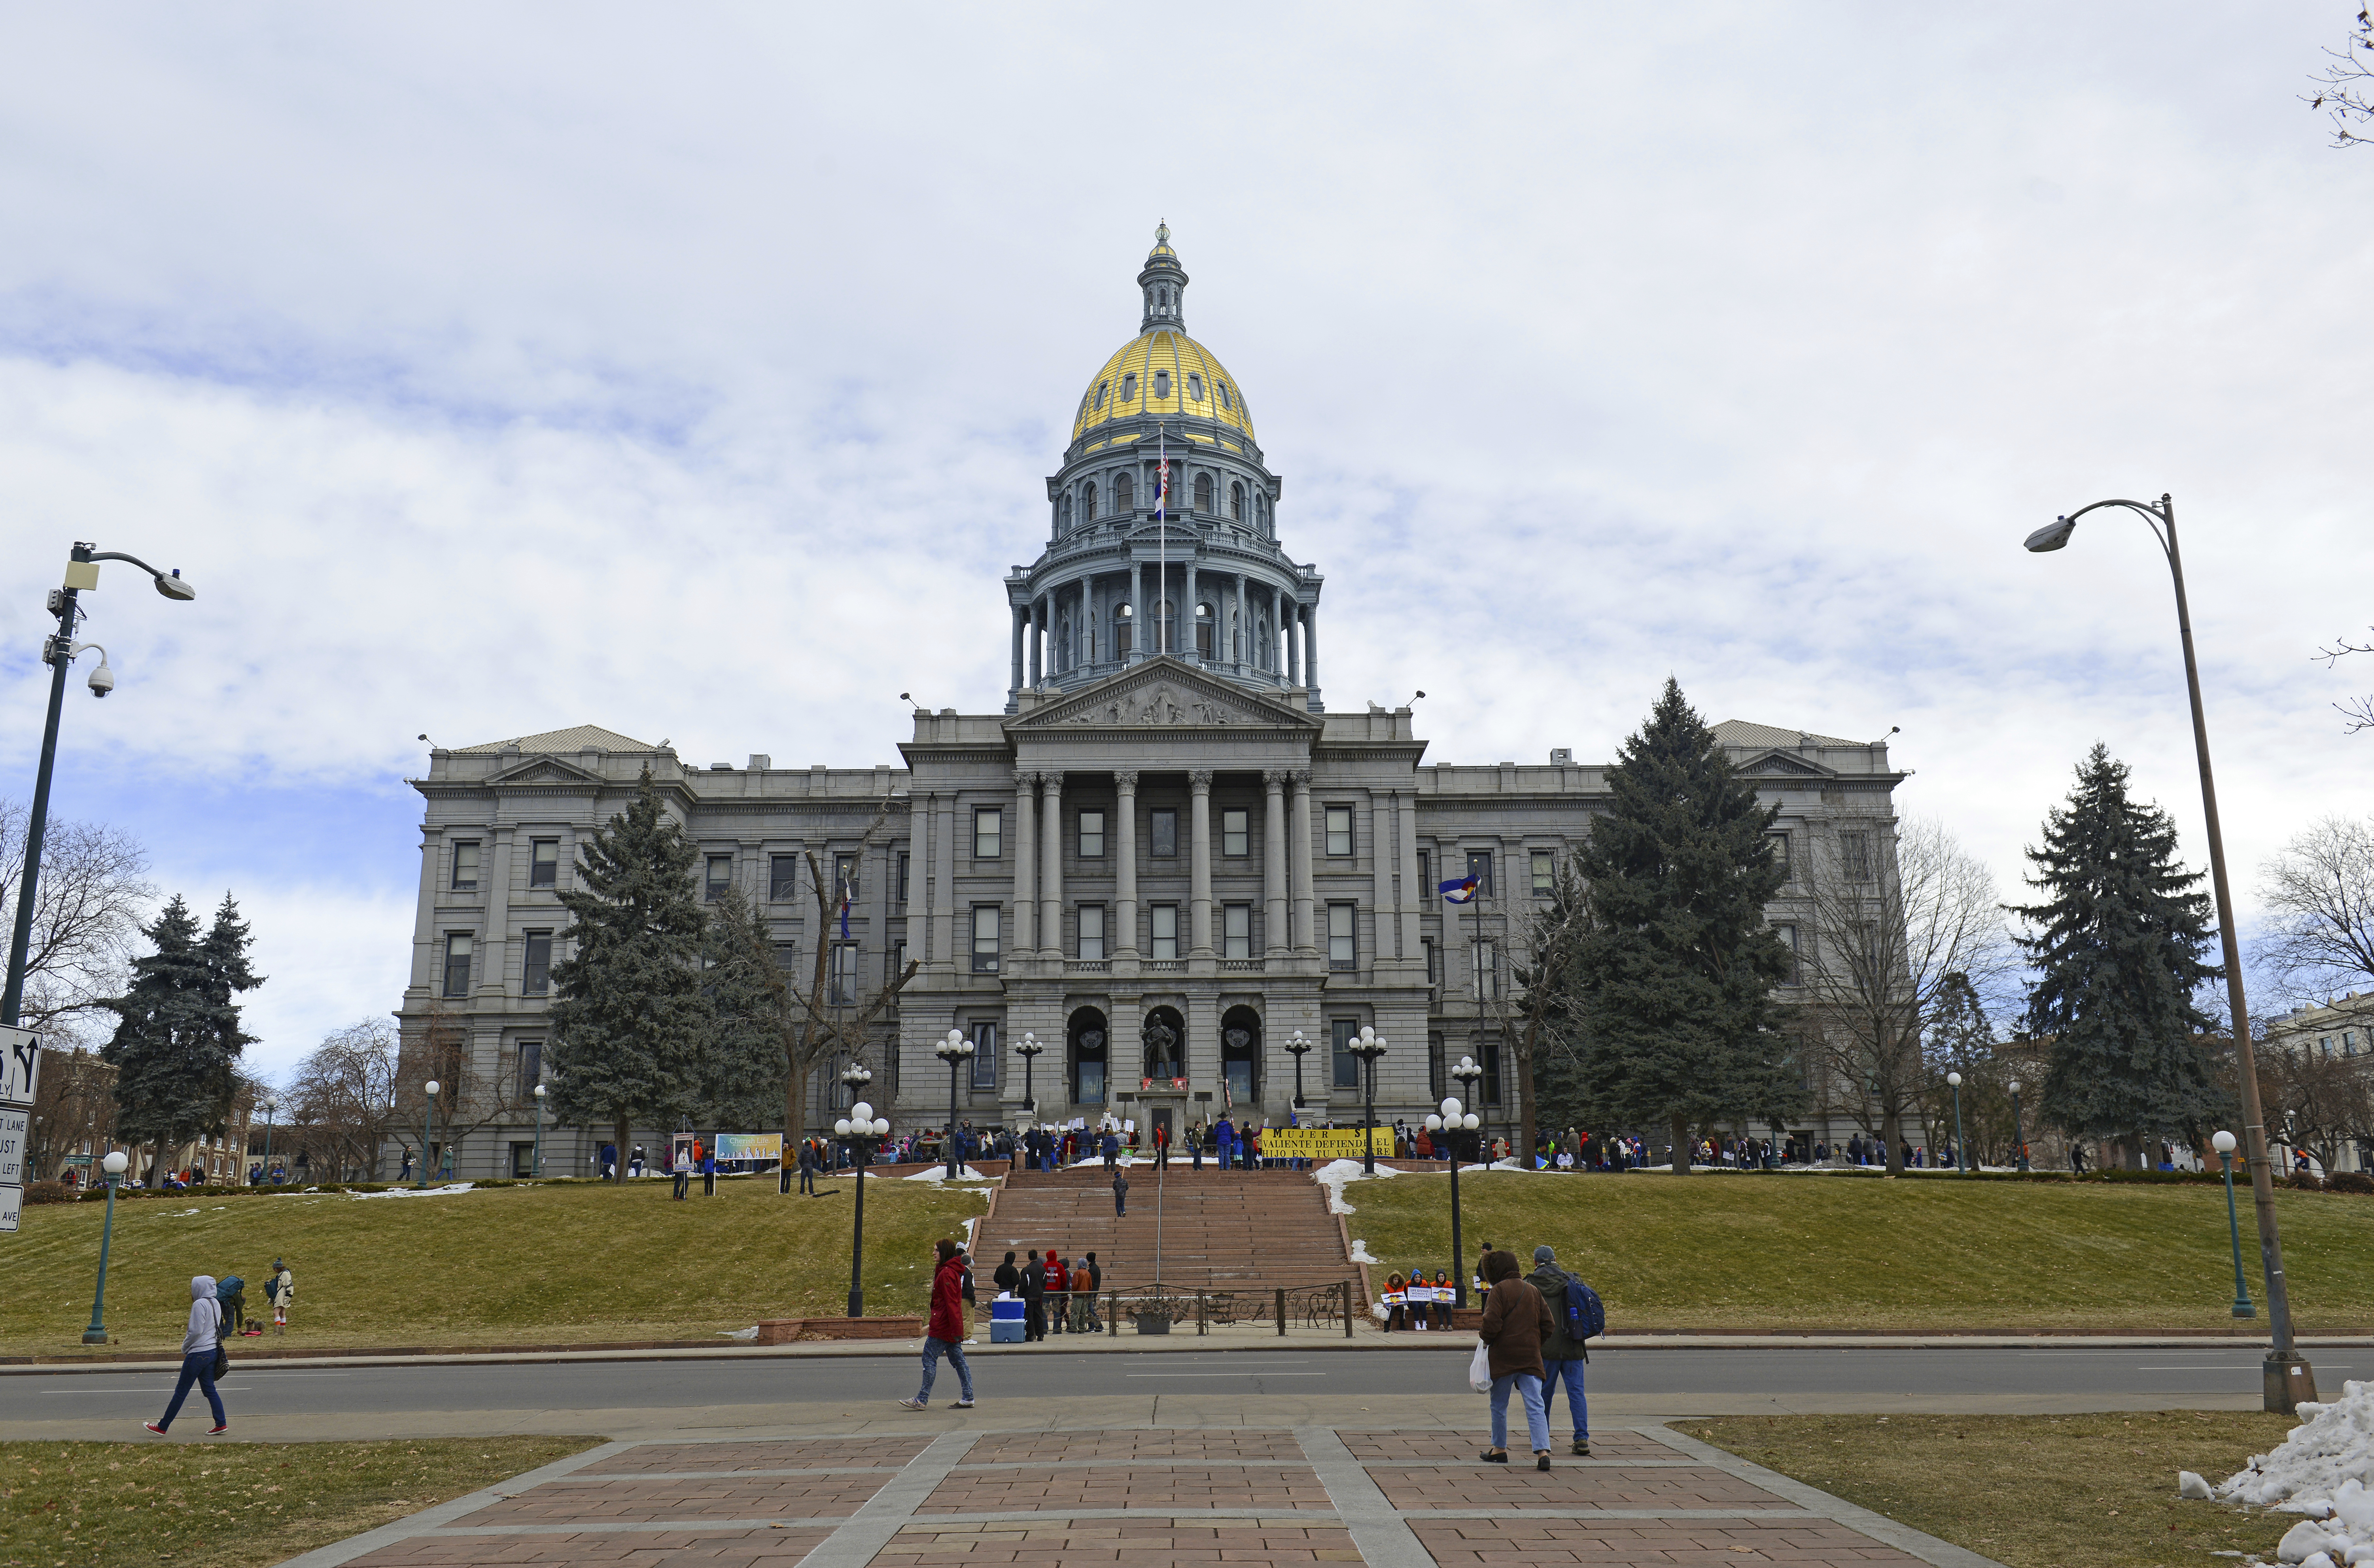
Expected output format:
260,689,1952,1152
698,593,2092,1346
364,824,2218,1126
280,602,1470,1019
0,1433,601,1568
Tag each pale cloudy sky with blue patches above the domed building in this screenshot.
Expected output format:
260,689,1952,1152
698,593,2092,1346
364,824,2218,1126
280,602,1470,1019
0,0,2374,1070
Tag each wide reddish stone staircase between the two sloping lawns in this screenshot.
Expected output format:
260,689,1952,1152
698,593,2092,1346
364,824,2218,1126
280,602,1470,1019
973,1160,1360,1293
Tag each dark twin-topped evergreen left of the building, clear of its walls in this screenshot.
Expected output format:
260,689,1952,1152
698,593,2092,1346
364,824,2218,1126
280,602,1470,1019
100,894,263,1177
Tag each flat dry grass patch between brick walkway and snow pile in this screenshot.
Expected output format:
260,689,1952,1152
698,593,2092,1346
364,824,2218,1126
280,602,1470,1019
1671,1404,2300,1568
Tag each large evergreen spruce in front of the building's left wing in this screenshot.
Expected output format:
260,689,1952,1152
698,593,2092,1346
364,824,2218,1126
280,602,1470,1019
546,769,712,1174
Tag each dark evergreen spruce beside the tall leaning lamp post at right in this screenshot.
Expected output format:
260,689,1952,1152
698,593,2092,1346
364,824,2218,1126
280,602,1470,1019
2013,742,2234,1162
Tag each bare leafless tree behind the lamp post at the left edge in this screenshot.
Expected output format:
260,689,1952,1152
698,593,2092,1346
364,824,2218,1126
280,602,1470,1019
0,799,157,1046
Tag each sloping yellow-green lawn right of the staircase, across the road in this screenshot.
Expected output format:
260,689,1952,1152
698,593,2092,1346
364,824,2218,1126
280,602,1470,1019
1339,1172,2374,1333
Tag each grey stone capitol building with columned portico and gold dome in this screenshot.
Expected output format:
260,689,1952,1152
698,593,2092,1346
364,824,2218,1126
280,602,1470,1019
399,230,1904,1177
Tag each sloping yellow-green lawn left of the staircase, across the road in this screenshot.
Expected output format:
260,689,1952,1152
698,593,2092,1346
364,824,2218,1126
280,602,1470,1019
0,1177,987,1357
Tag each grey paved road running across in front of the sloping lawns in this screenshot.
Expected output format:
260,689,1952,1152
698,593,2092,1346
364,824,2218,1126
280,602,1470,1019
0,1347,2336,1428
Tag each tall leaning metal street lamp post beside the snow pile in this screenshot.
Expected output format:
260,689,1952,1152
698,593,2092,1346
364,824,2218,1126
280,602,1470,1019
2025,493,2317,1416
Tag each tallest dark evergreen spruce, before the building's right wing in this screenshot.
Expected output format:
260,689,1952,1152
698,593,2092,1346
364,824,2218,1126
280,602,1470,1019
1574,678,1804,1174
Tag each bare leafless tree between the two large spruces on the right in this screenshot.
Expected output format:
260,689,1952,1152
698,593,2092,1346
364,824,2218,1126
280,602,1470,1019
1799,818,2013,1174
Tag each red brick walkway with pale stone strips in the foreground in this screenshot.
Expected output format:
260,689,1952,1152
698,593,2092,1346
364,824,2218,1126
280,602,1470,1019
292,1426,1992,1568
